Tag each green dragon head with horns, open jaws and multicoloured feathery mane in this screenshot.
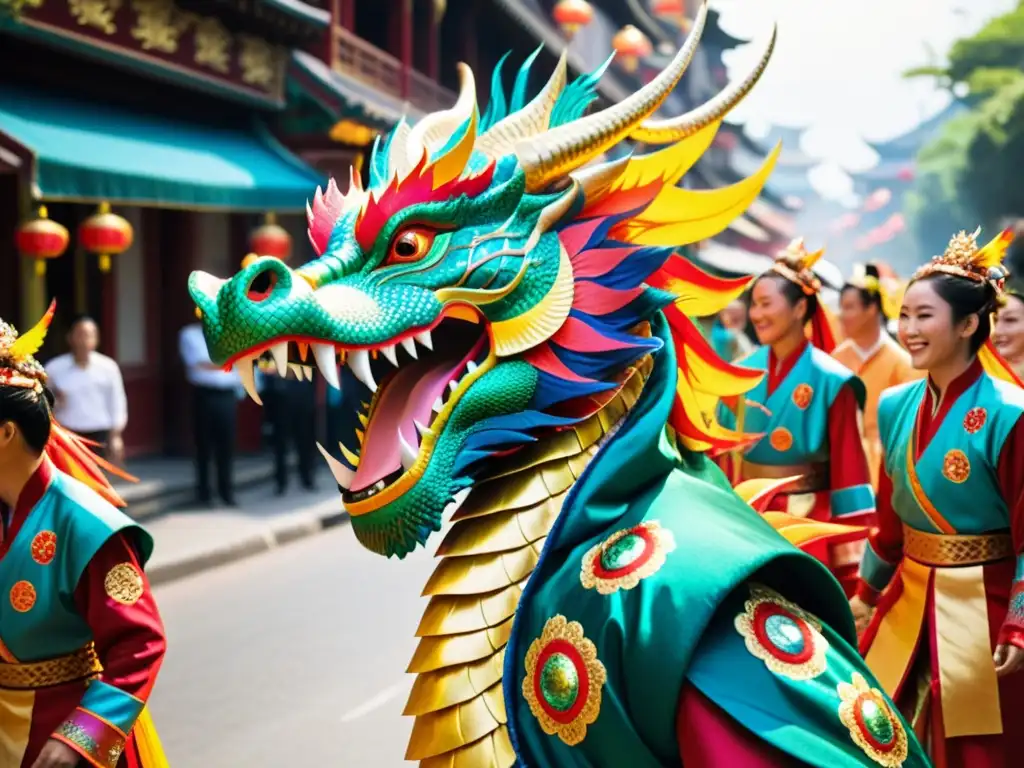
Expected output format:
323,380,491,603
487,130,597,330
189,7,778,557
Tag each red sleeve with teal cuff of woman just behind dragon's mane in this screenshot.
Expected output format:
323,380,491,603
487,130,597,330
828,384,874,525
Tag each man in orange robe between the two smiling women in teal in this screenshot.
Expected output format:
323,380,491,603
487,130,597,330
833,264,922,488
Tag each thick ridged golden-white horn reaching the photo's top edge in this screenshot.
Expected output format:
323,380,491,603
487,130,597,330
515,0,708,191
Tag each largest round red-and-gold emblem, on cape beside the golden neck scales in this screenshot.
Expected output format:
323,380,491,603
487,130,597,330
522,615,607,746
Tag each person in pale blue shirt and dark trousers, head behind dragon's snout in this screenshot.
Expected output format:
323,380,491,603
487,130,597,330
178,323,242,507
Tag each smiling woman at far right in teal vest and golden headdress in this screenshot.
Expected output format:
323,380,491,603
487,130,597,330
852,227,1024,768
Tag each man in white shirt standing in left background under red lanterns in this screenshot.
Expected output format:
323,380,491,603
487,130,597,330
46,315,128,464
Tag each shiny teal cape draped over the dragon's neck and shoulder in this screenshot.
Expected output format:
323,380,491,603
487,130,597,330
504,317,925,768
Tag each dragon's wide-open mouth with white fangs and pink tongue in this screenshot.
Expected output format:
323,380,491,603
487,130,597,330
233,310,493,503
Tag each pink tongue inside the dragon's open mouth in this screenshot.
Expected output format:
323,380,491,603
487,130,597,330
352,360,455,490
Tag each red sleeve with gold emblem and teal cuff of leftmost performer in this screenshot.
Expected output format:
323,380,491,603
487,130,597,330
53,534,166,768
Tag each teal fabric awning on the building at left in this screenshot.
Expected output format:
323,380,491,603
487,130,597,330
0,85,325,212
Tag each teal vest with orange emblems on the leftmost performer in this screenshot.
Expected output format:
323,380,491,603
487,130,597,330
0,470,153,663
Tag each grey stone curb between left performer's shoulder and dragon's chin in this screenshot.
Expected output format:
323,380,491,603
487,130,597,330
145,512,348,587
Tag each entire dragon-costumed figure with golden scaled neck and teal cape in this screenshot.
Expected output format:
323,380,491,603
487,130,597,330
189,6,928,768
